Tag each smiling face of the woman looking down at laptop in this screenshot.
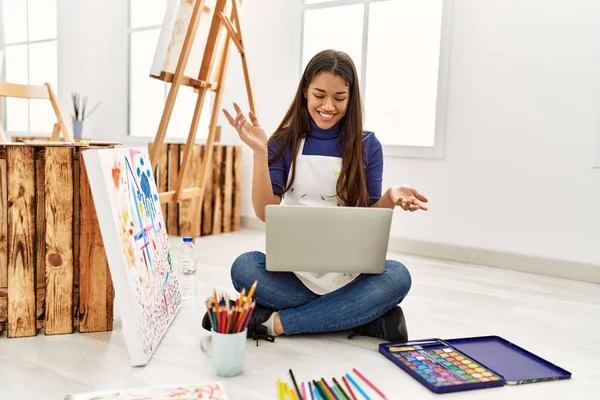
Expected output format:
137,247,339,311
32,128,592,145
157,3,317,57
304,72,350,129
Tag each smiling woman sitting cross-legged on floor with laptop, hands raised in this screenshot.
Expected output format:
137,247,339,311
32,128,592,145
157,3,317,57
203,50,427,341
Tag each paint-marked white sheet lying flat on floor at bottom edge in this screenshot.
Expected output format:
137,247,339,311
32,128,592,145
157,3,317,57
65,383,229,400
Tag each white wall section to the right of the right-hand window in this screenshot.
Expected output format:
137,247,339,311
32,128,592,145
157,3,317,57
384,0,600,267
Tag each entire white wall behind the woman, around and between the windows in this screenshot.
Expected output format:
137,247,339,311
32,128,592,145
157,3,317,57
59,0,600,265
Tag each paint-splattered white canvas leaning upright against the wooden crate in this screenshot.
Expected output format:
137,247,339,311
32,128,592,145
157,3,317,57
82,148,181,366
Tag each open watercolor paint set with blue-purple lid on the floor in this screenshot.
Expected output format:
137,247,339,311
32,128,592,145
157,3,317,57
379,336,571,393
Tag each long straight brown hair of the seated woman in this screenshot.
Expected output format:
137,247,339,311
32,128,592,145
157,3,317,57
269,50,369,207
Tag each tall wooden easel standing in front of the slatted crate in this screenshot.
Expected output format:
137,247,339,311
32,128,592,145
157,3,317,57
150,0,255,238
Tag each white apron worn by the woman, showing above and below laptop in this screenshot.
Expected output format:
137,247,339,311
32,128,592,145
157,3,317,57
281,139,358,295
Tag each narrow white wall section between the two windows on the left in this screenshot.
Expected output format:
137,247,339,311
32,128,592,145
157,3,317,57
58,0,131,147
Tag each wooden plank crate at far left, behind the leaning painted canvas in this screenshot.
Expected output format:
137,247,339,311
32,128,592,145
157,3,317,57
0,143,114,337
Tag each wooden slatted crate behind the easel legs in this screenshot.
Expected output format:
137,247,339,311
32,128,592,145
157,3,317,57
149,143,242,237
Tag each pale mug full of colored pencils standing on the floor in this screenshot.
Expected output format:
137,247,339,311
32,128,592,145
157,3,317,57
200,282,257,377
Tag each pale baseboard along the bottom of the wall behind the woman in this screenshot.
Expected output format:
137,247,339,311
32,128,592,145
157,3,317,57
241,216,600,283
